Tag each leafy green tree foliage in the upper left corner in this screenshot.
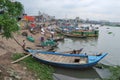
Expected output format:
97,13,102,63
0,0,23,38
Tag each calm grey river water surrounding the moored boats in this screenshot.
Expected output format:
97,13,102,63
55,26,120,79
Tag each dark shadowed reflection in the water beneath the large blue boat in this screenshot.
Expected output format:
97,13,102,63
55,67,100,79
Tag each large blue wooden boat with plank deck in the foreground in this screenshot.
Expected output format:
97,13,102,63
28,49,107,69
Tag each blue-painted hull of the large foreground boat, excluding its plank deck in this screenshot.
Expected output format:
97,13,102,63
28,51,107,69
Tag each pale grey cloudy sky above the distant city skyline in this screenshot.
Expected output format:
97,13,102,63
17,0,120,22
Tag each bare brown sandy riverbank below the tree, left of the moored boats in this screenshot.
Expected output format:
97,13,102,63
0,30,53,55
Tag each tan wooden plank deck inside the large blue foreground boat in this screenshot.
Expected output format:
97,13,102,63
36,53,87,64
